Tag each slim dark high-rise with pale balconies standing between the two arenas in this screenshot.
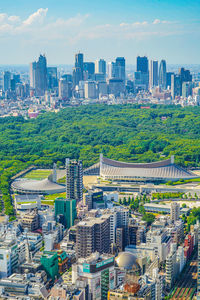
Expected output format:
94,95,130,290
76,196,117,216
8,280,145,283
65,158,83,202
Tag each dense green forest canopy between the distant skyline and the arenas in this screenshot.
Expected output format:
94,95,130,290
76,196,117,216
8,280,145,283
0,105,200,214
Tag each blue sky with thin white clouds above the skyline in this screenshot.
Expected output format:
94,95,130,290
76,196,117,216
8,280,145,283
0,0,200,65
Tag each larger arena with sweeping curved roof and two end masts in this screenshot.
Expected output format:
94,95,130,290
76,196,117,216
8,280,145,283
84,154,198,182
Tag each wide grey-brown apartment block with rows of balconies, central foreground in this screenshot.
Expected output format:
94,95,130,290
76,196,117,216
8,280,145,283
76,215,110,258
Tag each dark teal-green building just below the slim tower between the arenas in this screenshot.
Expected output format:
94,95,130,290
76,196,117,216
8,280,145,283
54,198,76,228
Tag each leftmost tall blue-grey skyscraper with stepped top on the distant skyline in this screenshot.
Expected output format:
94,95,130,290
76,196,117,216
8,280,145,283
30,55,47,96
